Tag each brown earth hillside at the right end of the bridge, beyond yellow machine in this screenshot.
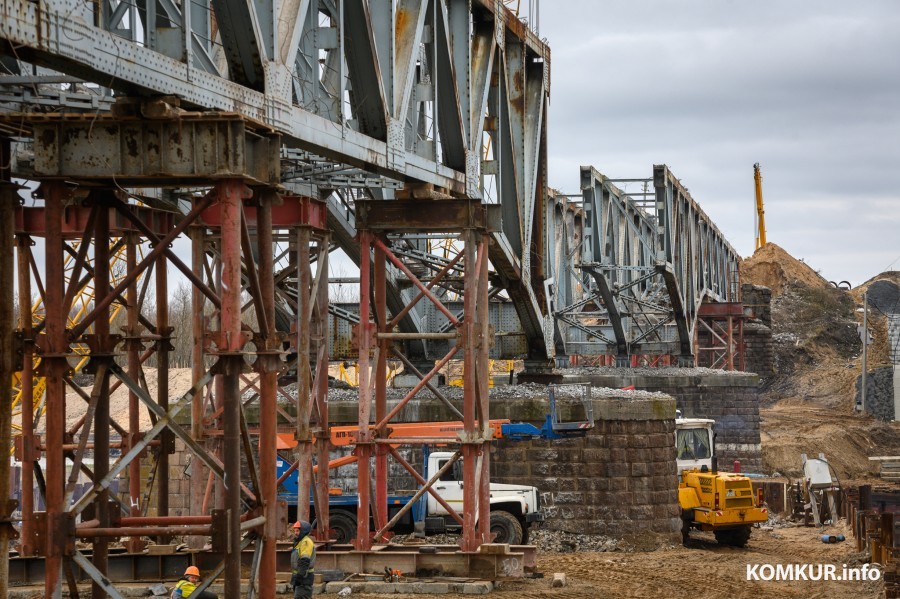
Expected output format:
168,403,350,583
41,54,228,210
741,243,900,480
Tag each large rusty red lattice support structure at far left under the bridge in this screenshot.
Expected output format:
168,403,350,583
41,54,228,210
0,103,338,599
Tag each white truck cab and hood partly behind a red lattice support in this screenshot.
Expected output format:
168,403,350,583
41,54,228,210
425,451,543,545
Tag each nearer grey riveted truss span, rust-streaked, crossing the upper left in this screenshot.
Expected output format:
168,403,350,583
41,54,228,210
0,0,553,359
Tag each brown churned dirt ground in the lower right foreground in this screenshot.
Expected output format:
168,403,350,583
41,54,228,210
342,525,883,599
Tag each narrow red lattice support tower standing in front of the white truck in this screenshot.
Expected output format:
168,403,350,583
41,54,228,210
354,200,499,551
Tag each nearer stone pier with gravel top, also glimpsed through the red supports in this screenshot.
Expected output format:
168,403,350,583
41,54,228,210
158,385,681,546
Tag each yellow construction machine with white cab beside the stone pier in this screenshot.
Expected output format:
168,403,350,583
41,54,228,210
675,418,769,547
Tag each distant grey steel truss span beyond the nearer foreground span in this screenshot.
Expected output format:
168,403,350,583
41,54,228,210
552,165,740,366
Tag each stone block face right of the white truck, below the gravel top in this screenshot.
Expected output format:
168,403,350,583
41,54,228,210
491,410,681,546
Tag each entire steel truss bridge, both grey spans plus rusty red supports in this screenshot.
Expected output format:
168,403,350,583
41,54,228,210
0,0,739,599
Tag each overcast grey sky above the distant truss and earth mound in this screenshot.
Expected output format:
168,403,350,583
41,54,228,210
536,0,900,286
